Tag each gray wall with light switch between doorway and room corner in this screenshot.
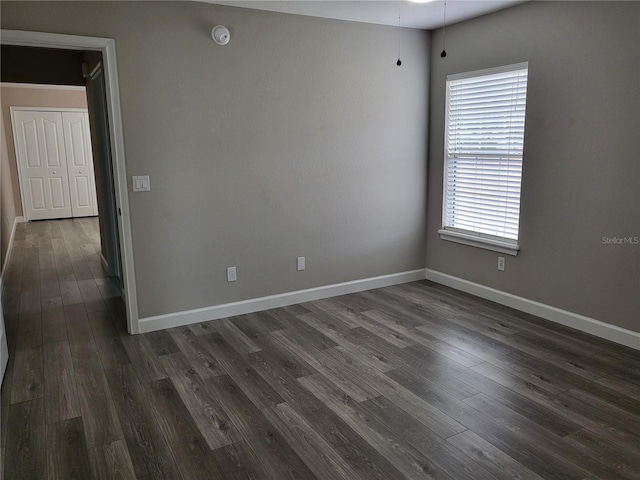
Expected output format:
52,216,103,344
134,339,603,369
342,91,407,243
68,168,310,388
1,2,430,317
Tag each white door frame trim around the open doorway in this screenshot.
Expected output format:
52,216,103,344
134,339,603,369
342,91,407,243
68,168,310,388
0,29,140,334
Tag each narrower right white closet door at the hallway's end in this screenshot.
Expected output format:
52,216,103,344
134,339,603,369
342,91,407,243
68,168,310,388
62,112,98,217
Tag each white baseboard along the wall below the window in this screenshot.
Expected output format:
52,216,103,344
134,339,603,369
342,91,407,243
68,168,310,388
426,269,640,350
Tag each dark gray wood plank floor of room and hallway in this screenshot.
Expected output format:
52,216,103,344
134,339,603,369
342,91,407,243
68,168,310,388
1,219,640,480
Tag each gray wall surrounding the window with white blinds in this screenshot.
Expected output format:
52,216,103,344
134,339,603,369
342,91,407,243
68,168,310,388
427,2,640,331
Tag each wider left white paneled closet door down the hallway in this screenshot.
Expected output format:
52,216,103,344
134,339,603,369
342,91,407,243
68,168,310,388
13,110,71,220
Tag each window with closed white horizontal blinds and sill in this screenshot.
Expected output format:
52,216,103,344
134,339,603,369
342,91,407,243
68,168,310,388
438,62,528,255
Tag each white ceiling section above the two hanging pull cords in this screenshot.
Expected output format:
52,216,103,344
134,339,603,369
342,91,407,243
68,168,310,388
199,0,525,30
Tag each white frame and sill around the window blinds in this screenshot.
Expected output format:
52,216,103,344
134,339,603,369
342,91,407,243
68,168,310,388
438,62,529,255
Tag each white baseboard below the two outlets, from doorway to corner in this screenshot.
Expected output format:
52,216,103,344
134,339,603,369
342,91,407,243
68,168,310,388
139,269,425,333
